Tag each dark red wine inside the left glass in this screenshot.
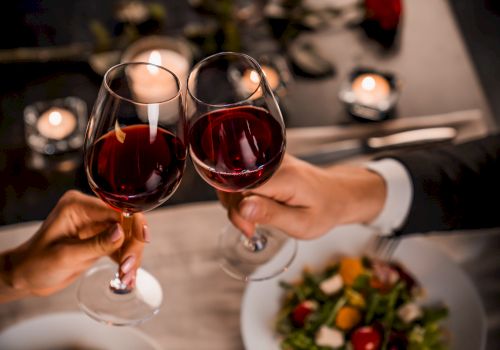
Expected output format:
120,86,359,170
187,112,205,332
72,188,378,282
87,125,186,213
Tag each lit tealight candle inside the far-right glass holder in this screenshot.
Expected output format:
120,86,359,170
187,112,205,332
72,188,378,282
352,74,391,106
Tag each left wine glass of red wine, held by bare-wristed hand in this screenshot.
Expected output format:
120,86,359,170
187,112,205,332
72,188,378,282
78,63,187,325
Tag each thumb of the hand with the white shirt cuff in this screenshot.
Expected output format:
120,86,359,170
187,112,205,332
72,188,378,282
238,195,310,237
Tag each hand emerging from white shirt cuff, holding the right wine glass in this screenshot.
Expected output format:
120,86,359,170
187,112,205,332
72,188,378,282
218,155,386,239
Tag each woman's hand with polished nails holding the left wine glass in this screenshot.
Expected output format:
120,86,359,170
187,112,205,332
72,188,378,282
0,191,149,301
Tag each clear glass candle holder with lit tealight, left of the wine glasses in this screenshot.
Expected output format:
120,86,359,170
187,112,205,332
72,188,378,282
24,97,88,155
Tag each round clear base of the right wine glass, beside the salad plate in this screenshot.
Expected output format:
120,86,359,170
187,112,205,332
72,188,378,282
219,225,297,282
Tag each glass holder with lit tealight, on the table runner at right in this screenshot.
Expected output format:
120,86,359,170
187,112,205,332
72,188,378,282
339,68,400,121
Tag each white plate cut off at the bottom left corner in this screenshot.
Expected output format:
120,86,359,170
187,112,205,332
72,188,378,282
0,312,160,350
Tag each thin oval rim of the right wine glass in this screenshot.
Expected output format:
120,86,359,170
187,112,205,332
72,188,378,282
186,51,266,108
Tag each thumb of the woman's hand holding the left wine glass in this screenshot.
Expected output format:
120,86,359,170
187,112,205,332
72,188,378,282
73,224,125,260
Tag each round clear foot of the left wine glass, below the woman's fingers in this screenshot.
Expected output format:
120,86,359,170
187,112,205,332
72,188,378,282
77,264,163,326
